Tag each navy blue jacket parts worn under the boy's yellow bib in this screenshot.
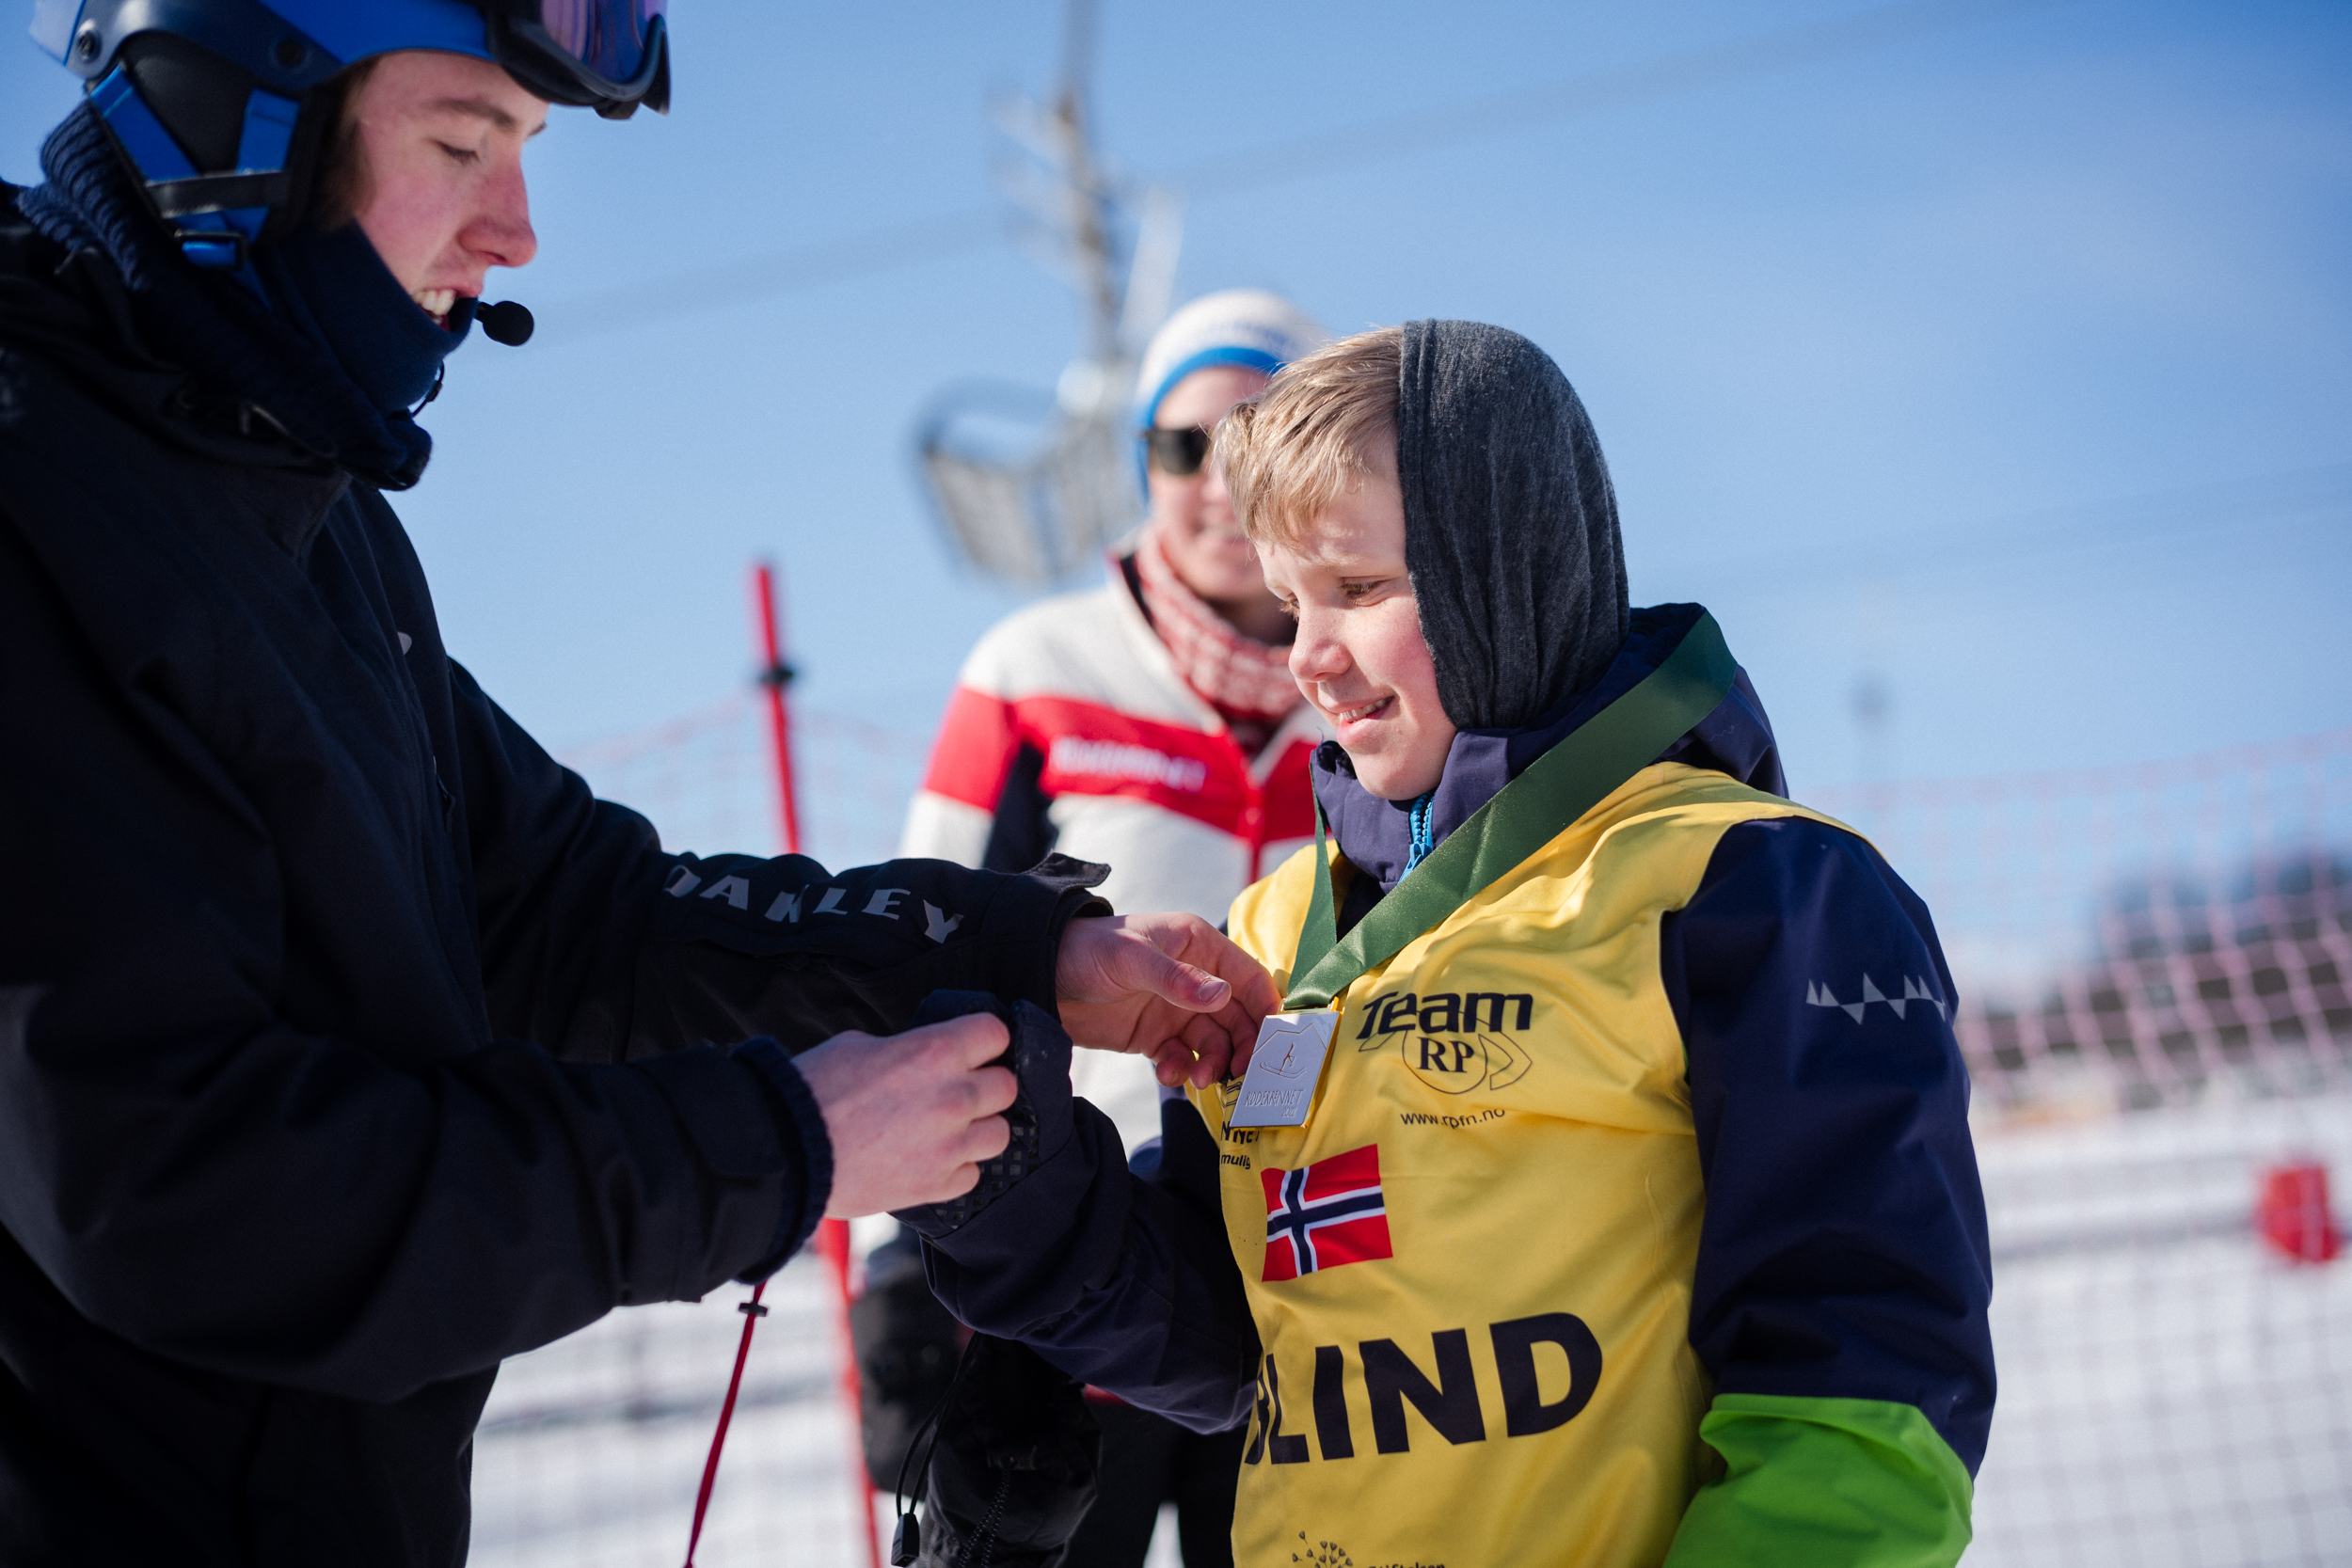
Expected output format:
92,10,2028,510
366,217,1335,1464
911,607,1994,1474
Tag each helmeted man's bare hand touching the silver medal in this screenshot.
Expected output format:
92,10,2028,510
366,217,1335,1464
1054,914,1282,1088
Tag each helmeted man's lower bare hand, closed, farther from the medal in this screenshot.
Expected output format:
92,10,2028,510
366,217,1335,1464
793,1013,1019,1220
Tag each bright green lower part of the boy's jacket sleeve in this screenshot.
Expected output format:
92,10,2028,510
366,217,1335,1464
1665,1394,1974,1568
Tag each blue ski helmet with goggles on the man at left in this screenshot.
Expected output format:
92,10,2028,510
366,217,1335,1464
33,0,671,268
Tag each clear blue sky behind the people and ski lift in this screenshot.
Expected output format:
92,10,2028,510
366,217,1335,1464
0,0,2352,795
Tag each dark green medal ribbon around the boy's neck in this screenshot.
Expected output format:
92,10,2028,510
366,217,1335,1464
1282,613,1739,1013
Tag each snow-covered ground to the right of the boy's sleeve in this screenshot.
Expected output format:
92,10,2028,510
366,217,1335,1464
1969,1096,2352,1568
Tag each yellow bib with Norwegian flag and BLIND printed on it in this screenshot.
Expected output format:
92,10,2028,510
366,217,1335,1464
1193,762,1814,1568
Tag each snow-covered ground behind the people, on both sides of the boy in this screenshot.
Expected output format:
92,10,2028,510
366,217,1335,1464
473,1096,2352,1568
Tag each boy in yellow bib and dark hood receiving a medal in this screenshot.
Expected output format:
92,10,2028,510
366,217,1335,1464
889,322,1994,1568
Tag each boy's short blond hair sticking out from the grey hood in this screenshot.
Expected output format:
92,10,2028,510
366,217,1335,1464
1216,326,1405,546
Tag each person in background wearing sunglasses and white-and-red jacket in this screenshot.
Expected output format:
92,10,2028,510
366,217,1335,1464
884,289,1329,1568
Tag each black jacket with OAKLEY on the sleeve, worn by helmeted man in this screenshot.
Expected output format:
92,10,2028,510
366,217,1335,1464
0,185,1099,1568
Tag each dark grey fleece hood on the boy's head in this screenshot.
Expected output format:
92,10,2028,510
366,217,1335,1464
1397,322,1628,729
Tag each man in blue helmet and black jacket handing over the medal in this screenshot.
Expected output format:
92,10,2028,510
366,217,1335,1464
0,0,1265,1568
